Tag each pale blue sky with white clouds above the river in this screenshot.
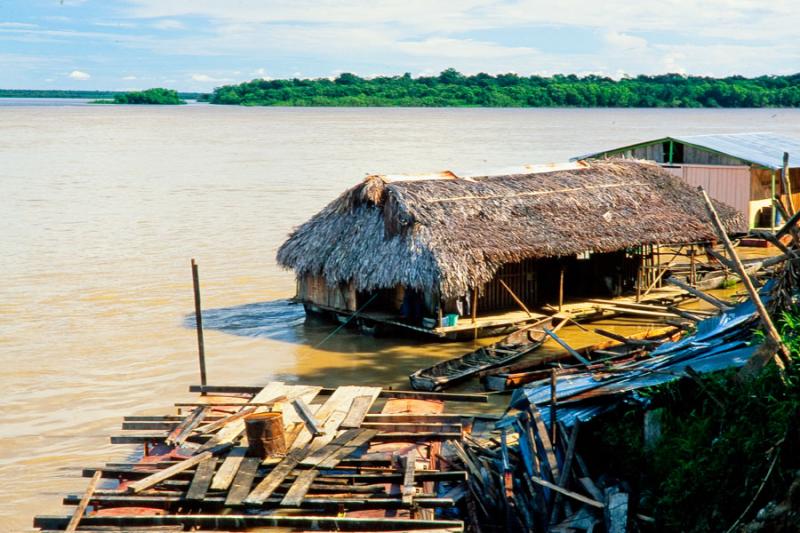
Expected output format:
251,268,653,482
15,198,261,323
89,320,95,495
0,0,800,91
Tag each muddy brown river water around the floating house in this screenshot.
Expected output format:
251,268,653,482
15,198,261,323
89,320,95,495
0,101,800,532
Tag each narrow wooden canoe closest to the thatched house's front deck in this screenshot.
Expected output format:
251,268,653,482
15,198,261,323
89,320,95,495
408,317,558,391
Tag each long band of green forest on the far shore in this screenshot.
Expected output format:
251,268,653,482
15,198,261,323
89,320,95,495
208,69,800,107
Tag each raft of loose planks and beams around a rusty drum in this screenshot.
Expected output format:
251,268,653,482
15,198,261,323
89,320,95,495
34,382,486,531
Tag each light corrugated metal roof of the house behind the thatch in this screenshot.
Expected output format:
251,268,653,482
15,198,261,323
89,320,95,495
573,132,800,169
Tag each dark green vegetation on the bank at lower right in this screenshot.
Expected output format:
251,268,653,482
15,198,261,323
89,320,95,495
584,311,800,532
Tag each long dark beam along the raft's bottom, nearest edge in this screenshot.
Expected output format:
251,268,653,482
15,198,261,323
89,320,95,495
34,514,464,531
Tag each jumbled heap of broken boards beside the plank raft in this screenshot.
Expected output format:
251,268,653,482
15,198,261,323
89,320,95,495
454,406,644,533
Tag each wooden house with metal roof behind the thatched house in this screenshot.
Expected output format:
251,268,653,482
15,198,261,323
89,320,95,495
573,133,800,228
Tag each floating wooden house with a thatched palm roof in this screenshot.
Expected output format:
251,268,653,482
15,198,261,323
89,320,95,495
277,160,745,336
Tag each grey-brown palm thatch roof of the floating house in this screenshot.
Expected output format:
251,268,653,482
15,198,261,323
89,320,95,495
278,160,746,297
